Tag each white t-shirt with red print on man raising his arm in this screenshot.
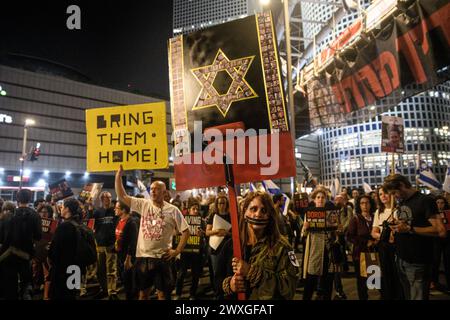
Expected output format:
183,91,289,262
131,197,189,258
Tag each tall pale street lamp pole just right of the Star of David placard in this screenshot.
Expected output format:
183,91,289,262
260,0,297,195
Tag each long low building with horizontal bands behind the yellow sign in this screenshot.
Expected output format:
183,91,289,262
0,57,173,199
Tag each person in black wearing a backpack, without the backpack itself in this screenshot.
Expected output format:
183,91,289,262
48,198,82,300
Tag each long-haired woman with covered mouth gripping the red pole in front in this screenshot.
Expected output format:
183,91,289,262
222,191,299,300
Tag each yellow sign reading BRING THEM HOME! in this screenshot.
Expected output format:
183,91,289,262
86,102,168,172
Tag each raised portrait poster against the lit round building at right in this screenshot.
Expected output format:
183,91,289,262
381,116,405,153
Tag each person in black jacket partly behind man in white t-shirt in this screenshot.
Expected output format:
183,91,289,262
115,201,138,300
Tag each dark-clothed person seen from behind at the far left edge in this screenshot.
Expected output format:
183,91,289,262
0,189,42,300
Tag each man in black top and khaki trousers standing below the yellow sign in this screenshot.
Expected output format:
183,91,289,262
94,191,118,300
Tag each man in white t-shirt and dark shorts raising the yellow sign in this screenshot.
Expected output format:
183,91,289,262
115,166,189,300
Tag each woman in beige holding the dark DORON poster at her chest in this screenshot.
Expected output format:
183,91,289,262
302,188,338,300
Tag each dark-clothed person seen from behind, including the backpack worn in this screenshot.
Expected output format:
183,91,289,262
48,198,97,300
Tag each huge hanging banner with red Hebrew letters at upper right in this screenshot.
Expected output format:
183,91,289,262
306,0,450,130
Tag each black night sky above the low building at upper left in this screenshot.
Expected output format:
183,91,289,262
0,0,172,98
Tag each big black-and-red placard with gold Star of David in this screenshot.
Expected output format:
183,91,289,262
169,13,295,190
